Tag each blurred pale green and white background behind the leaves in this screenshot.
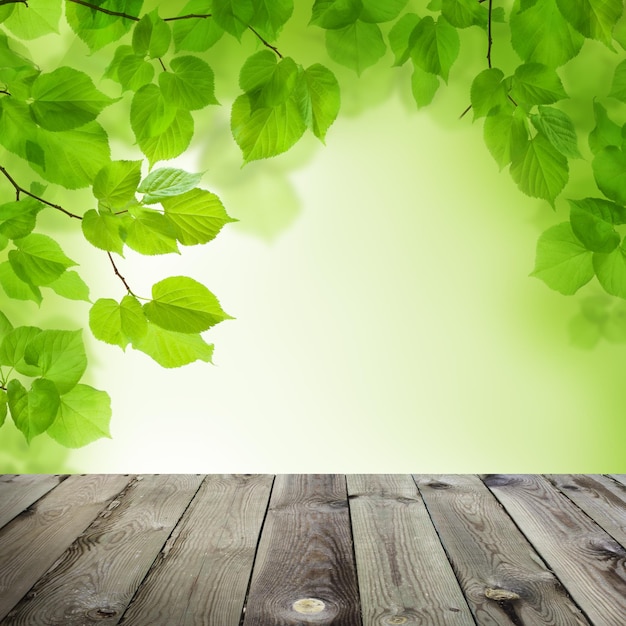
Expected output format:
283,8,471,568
0,3,626,473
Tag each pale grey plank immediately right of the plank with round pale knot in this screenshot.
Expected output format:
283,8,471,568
347,475,475,626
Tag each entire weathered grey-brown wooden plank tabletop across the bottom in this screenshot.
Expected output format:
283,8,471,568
0,474,626,626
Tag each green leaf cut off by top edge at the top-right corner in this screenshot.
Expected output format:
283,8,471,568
557,0,624,48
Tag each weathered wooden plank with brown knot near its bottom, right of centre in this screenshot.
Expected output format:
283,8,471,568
414,475,588,626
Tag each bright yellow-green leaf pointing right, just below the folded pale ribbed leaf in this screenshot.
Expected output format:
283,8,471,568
161,189,234,246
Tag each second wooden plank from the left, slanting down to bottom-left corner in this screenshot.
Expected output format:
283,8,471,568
0,474,130,619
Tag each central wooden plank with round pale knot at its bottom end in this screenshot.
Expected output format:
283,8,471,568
243,474,361,626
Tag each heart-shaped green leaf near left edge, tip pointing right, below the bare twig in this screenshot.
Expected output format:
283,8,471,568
9,233,76,286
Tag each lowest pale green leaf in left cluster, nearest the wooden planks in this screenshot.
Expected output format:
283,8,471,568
47,385,111,448
